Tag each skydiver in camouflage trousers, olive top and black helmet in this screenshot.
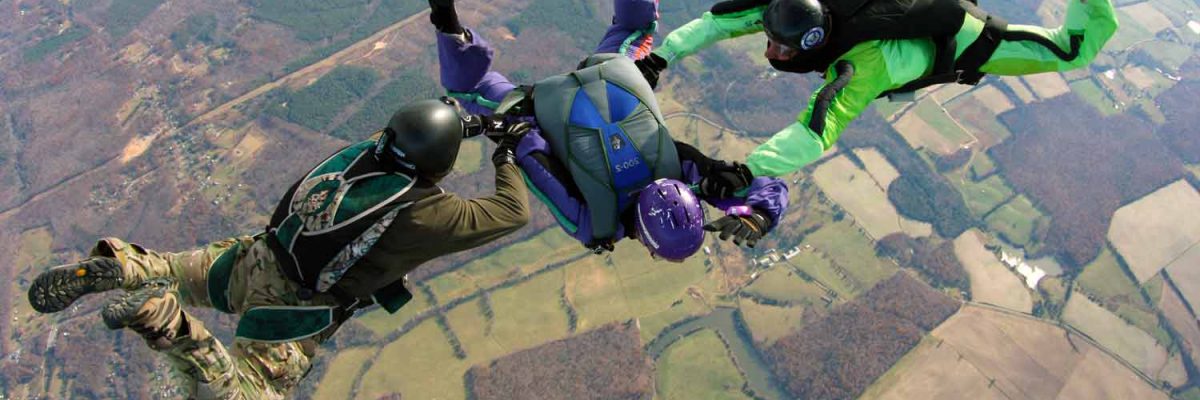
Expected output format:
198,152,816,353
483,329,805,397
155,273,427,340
29,98,529,400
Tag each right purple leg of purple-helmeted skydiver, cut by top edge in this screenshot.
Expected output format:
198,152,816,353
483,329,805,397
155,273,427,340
595,0,659,60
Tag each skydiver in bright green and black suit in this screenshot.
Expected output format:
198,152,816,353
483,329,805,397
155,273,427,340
637,0,1117,177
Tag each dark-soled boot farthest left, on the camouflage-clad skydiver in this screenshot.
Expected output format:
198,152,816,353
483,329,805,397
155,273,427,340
29,257,125,314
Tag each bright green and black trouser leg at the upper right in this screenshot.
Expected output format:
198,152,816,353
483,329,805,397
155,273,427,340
980,0,1117,76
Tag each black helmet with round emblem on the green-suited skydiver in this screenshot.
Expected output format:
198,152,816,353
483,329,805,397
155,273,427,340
762,0,829,50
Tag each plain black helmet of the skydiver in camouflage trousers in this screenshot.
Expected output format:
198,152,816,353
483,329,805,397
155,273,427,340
386,97,464,181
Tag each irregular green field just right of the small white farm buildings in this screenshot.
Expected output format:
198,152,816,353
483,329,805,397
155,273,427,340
793,219,896,294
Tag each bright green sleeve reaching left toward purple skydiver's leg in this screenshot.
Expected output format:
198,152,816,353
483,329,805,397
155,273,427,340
654,0,769,64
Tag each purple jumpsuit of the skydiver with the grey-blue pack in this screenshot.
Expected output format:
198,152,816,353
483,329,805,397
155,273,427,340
437,0,787,246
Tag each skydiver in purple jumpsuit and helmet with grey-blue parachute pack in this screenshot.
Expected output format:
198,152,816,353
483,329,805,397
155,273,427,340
430,0,787,258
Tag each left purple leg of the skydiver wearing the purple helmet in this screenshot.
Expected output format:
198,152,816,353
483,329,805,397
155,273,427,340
430,0,516,114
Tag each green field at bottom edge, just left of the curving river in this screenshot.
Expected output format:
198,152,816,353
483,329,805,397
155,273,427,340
656,329,749,399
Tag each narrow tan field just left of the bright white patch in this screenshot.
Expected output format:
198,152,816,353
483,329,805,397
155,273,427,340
954,229,1033,312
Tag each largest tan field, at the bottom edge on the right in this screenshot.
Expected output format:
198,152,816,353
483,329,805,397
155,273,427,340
863,305,1168,400
